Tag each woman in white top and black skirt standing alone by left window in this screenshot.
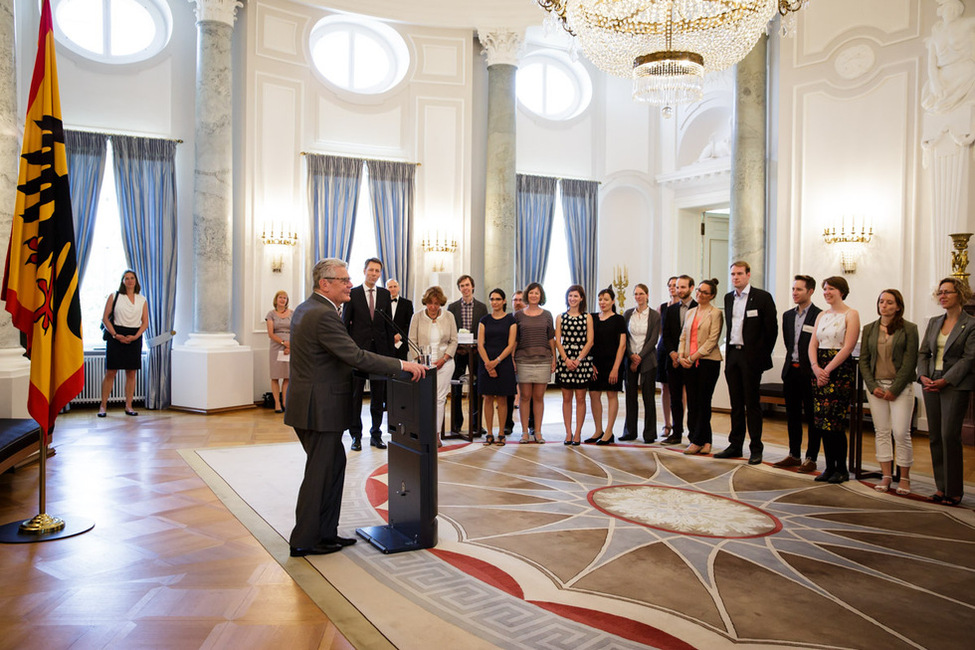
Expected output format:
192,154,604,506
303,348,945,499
98,269,149,418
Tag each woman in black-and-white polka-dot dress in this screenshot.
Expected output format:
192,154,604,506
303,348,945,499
555,284,592,446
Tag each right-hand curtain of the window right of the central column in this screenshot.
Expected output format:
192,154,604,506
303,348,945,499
562,180,599,296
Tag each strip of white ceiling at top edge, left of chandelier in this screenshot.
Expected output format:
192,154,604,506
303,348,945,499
302,0,546,31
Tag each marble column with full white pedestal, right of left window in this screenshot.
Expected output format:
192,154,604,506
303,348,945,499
173,0,254,412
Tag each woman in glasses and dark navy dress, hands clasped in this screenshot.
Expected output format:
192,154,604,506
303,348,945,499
477,289,518,445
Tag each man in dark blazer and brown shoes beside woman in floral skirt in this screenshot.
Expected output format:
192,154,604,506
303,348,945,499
772,275,821,473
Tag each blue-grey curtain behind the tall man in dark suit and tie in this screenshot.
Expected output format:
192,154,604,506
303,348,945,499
366,160,416,296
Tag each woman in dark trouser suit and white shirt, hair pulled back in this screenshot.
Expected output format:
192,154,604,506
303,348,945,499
620,284,660,443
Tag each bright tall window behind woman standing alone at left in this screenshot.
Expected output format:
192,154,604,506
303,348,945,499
80,141,132,349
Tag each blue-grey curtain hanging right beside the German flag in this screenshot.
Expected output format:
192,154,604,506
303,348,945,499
64,130,108,287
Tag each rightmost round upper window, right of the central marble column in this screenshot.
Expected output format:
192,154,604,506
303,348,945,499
517,51,592,120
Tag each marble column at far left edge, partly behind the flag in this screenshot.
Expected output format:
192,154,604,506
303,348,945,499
0,0,30,418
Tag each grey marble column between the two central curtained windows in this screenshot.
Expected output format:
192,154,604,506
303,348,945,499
477,29,522,292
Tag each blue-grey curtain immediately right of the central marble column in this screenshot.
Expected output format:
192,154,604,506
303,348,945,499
515,174,558,289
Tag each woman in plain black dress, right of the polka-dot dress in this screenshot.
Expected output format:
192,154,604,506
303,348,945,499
586,287,626,445
